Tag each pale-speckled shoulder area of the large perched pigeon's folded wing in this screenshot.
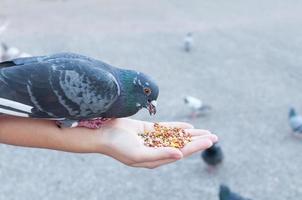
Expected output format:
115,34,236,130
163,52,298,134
50,61,119,117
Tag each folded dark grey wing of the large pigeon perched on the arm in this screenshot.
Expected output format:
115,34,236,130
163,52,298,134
0,57,119,119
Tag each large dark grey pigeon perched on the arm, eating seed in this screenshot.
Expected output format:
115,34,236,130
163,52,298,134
0,53,159,128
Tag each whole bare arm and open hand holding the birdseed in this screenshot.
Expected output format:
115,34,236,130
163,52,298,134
0,116,217,168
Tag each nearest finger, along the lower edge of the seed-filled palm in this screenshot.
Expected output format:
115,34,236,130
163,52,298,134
133,147,183,163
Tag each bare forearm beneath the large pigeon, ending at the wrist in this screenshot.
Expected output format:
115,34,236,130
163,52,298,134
0,116,99,153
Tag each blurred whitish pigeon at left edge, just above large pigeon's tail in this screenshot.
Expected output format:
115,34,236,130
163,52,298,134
0,43,31,62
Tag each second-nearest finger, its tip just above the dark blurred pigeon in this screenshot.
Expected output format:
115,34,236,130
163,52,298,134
181,138,213,157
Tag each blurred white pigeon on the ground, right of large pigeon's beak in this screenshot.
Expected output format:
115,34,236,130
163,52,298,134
184,96,211,118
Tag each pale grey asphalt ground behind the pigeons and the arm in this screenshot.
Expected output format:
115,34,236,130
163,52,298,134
0,0,302,200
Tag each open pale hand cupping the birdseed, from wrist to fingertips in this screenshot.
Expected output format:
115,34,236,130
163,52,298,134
97,118,217,168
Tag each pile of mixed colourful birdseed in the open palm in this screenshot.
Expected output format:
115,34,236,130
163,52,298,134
139,123,192,149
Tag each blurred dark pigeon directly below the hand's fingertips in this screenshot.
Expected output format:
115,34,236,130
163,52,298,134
201,143,224,167
